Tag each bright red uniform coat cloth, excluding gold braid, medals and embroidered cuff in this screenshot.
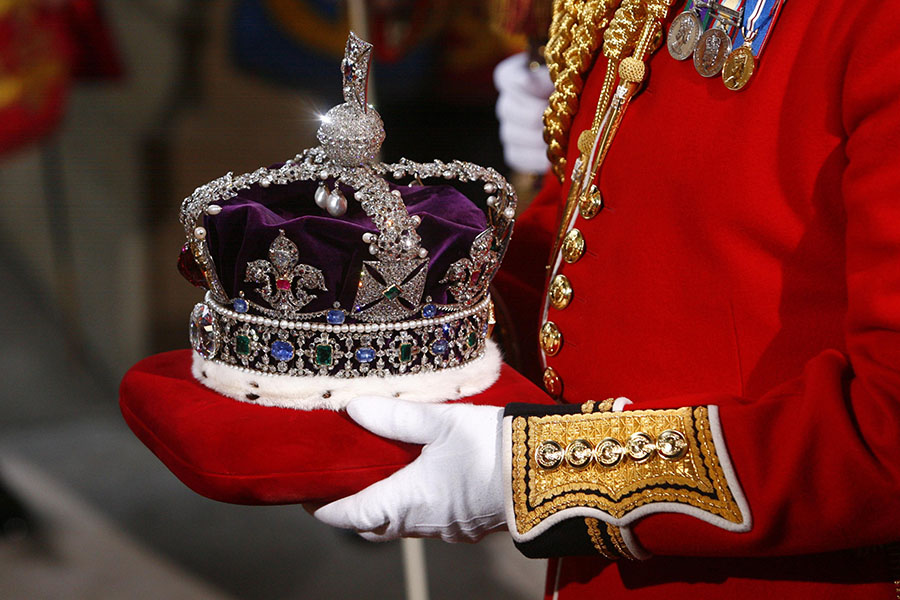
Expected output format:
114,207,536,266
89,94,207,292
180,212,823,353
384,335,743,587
501,0,900,599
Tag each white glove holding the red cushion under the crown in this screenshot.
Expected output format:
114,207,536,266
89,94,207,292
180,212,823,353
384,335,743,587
313,397,506,542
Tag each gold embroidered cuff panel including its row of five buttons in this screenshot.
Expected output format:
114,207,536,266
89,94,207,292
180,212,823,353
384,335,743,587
510,407,749,539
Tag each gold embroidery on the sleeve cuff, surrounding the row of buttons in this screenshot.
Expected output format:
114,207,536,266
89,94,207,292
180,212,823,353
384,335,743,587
512,407,743,533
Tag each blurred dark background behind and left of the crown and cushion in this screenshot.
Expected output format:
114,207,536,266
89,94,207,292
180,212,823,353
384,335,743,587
0,0,546,599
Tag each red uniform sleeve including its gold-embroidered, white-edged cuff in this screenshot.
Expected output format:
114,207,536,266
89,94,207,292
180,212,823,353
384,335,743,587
504,15,900,558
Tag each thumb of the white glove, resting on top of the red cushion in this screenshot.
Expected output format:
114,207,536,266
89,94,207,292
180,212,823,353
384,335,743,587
347,396,446,444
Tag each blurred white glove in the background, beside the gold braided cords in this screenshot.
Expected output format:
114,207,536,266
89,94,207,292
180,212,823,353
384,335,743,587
494,52,553,174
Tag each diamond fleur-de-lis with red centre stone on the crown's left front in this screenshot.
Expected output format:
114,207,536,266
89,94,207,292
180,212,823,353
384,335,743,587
244,229,328,317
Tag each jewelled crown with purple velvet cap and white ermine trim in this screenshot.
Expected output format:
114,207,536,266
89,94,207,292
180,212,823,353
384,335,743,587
179,33,516,409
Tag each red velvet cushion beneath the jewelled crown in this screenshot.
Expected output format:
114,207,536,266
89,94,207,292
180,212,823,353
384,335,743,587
119,350,550,504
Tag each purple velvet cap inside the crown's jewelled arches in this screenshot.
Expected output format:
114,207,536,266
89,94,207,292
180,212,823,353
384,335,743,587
204,176,487,317
